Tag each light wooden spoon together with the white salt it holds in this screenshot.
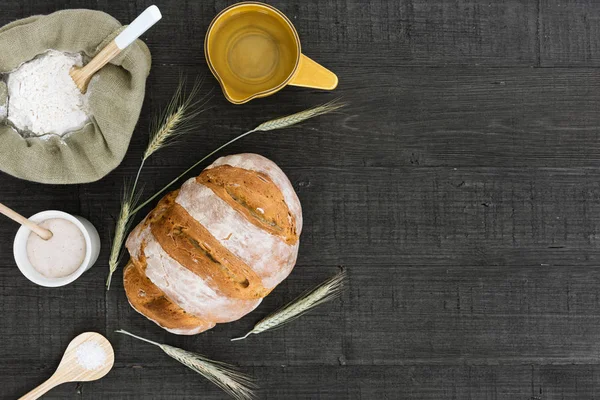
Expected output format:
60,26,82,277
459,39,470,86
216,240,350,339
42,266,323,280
20,332,115,400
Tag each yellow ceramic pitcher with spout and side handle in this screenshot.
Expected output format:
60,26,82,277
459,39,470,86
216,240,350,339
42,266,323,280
204,2,338,104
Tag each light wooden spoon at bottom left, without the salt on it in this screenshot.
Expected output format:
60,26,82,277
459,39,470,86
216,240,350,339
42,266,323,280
20,332,115,400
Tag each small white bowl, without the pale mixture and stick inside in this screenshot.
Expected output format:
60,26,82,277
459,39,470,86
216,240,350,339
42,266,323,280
13,210,100,287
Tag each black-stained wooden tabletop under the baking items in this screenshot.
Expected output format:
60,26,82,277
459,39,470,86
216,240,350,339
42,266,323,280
0,0,600,400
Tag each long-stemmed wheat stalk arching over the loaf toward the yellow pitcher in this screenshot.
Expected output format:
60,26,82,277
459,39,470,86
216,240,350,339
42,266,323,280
133,100,346,213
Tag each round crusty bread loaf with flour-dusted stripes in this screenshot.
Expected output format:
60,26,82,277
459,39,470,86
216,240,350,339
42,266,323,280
123,154,302,335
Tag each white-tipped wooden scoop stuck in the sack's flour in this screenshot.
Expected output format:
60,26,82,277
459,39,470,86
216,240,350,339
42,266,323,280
69,6,162,93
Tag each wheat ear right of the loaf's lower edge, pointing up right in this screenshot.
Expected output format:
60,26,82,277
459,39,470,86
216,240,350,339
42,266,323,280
231,269,347,341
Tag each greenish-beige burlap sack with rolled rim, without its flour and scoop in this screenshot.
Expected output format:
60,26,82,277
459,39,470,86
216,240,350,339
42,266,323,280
0,10,151,184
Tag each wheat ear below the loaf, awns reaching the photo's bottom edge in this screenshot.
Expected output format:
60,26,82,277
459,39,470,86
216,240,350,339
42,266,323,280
115,329,258,400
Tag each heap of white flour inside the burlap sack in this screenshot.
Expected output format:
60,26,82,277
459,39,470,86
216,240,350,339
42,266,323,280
6,50,89,136
